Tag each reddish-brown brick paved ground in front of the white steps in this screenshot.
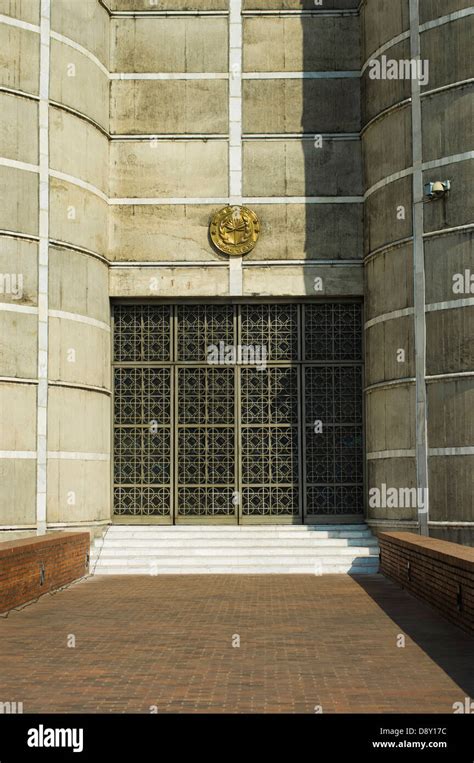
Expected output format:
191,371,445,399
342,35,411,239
0,575,474,713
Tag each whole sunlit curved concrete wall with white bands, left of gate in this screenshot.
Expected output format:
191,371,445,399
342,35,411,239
0,0,111,529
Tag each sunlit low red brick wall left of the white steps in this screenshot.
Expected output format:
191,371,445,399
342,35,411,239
0,532,90,612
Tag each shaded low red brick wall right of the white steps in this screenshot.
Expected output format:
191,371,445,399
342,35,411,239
378,532,474,634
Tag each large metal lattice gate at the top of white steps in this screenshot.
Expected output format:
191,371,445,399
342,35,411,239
113,302,363,524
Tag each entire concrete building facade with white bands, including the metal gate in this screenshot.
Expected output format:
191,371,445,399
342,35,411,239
0,0,474,545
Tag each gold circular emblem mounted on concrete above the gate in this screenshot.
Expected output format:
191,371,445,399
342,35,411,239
209,205,260,254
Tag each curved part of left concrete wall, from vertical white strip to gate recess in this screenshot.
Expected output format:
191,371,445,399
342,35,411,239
47,0,111,526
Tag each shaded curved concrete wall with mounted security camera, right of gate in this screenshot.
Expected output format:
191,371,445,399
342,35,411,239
361,0,474,544
